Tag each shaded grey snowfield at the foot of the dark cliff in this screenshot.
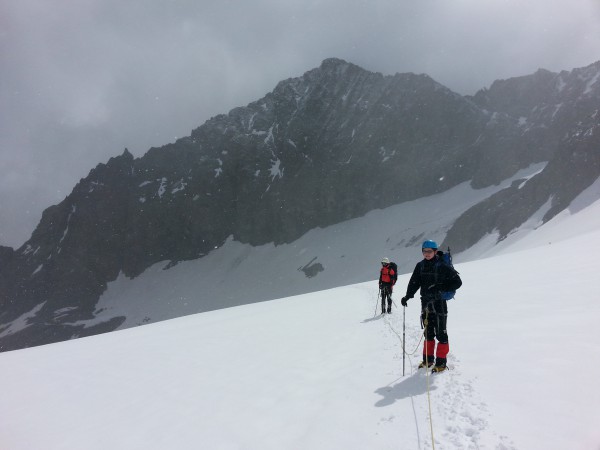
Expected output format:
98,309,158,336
81,163,548,331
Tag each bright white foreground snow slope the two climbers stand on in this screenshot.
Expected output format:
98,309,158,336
0,192,600,450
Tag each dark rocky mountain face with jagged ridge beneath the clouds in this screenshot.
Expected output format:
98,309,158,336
0,59,600,350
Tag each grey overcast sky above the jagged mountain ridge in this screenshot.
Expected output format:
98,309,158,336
0,0,600,248
